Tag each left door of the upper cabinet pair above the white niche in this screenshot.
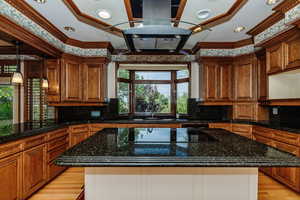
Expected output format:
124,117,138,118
267,44,284,74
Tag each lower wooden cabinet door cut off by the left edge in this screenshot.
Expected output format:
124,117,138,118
0,154,22,200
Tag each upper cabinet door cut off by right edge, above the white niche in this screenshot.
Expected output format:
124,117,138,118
285,34,300,69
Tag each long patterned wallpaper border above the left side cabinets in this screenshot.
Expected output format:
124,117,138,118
0,0,110,57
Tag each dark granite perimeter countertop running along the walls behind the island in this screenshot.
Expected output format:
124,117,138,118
0,119,300,144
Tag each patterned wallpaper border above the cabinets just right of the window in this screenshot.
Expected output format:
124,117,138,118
197,44,255,57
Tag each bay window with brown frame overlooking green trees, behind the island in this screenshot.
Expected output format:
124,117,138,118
117,68,190,116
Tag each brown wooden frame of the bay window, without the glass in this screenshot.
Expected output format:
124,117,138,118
116,63,191,117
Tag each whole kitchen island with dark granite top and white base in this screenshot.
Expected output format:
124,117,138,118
56,128,300,200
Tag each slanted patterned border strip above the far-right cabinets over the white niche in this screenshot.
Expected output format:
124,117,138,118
254,19,290,44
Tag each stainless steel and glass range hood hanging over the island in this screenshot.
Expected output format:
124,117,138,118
123,0,192,52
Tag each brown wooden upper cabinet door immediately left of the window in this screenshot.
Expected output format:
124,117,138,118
83,63,107,103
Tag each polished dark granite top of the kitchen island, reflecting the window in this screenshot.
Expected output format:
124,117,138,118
55,128,300,167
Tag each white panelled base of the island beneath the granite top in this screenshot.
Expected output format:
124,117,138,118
85,167,258,200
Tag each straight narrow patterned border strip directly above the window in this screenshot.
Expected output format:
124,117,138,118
111,55,196,62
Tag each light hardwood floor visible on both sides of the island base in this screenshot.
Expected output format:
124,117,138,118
29,168,300,200
